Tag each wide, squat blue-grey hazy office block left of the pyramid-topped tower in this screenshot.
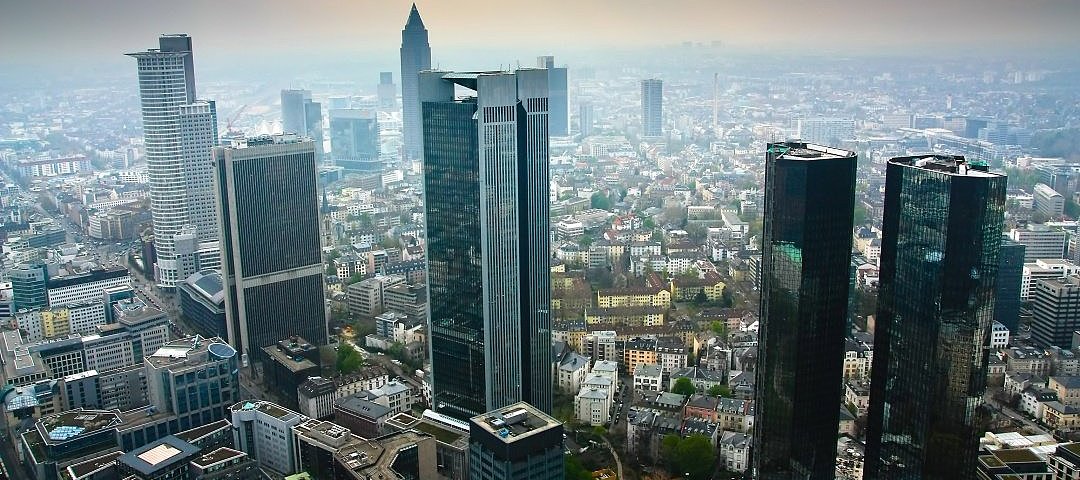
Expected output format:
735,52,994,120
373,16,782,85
330,109,382,172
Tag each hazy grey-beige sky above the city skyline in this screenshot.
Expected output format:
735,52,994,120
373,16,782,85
0,0,1080,68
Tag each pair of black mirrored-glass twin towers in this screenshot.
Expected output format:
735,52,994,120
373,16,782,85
754,143,1005,480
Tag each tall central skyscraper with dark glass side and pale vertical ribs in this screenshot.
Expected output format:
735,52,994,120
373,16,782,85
419,69,552,418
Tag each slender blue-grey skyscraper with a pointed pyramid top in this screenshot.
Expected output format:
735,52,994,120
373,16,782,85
399,3,431,159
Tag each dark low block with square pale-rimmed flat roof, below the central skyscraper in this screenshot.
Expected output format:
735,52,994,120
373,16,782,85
469,402,565,480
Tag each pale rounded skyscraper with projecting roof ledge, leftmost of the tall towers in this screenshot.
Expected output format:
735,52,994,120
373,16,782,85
127,35,219,289
